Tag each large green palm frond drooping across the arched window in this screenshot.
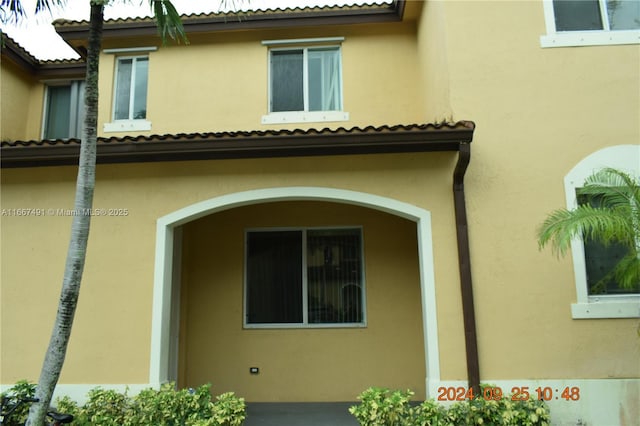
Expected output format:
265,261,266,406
538,205,636,256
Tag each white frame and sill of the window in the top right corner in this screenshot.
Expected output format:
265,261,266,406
540,0,640,47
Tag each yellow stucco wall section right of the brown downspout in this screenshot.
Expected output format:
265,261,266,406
430,1,640,380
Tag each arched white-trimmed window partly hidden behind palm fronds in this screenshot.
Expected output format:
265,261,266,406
564,145,640,318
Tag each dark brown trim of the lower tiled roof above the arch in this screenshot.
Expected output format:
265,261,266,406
0,121,475,168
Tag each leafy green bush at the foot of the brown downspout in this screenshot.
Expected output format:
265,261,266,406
349,388,550,426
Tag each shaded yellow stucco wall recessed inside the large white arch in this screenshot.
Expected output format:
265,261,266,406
180,202,425,401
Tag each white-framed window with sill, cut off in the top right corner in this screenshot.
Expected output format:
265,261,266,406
540,0,640,47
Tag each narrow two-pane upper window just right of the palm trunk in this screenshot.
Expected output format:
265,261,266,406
105,56,151,131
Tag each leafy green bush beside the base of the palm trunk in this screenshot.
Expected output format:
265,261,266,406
3,383,246,426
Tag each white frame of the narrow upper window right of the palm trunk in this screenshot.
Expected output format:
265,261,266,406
103,46,157,132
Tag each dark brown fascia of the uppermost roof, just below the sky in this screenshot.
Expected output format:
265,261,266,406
54,0,405,50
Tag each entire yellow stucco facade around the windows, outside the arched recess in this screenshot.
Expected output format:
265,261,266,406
0,1,640,418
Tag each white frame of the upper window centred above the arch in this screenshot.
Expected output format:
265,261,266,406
262,37,349,124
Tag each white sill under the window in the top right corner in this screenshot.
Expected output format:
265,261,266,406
540,30,640,47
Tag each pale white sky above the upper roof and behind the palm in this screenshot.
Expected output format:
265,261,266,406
0,0,388,60
